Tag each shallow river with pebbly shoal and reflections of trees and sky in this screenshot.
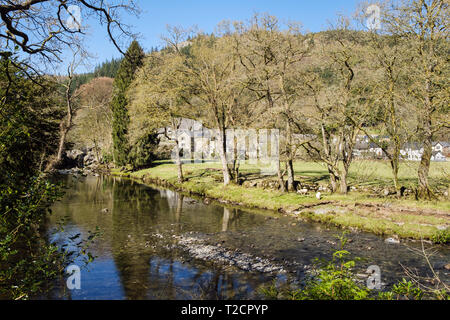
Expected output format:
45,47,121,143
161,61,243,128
44,176,450,300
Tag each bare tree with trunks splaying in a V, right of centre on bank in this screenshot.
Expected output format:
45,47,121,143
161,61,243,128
302,23,368,194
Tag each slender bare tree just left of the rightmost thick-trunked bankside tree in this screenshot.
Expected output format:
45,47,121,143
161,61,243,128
357,3,412,197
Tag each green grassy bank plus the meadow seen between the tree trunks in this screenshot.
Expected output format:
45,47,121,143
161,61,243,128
112,162,450,242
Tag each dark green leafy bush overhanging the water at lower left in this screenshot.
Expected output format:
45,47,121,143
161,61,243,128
0,174,64,299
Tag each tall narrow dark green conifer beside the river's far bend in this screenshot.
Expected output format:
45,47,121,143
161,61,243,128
111,41,145,166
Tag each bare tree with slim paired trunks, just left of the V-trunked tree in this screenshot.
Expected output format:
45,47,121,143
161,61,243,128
234,15,312,192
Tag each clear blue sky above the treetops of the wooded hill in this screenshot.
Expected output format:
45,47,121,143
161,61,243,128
75,0,360,72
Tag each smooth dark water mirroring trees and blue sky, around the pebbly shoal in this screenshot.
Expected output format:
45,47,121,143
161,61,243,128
50,177,274,299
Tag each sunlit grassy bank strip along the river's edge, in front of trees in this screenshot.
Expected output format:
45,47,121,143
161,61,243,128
111,163,450,243
